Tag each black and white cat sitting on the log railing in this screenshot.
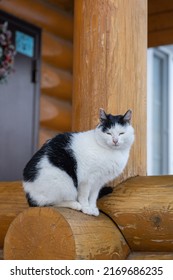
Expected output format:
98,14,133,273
23,109,134,216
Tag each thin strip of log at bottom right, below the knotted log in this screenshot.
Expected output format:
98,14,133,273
127,252,173,260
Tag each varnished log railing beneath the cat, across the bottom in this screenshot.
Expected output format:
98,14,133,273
0,176,173,259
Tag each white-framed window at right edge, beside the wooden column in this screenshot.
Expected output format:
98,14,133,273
147,46,173,175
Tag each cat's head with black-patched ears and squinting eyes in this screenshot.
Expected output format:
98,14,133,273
95,109,134,149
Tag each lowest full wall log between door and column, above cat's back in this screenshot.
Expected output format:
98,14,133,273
40,94,72,131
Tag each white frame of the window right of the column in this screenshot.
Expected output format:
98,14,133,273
147,46,173,175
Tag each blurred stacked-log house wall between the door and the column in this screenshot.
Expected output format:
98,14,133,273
0,0,73,145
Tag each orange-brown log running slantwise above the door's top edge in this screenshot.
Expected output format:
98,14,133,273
0,0,73,41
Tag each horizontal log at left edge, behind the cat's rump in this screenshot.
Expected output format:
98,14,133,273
0,182,28,249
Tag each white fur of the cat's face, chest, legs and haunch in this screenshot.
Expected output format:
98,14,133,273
23,124,134,216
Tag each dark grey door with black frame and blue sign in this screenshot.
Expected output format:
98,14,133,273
0,11,41,181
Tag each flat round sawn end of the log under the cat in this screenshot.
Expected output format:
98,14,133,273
4,208,75,260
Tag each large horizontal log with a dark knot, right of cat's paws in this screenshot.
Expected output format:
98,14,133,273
99,176,173,252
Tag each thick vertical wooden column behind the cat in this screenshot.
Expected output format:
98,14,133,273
73,0,147,183
